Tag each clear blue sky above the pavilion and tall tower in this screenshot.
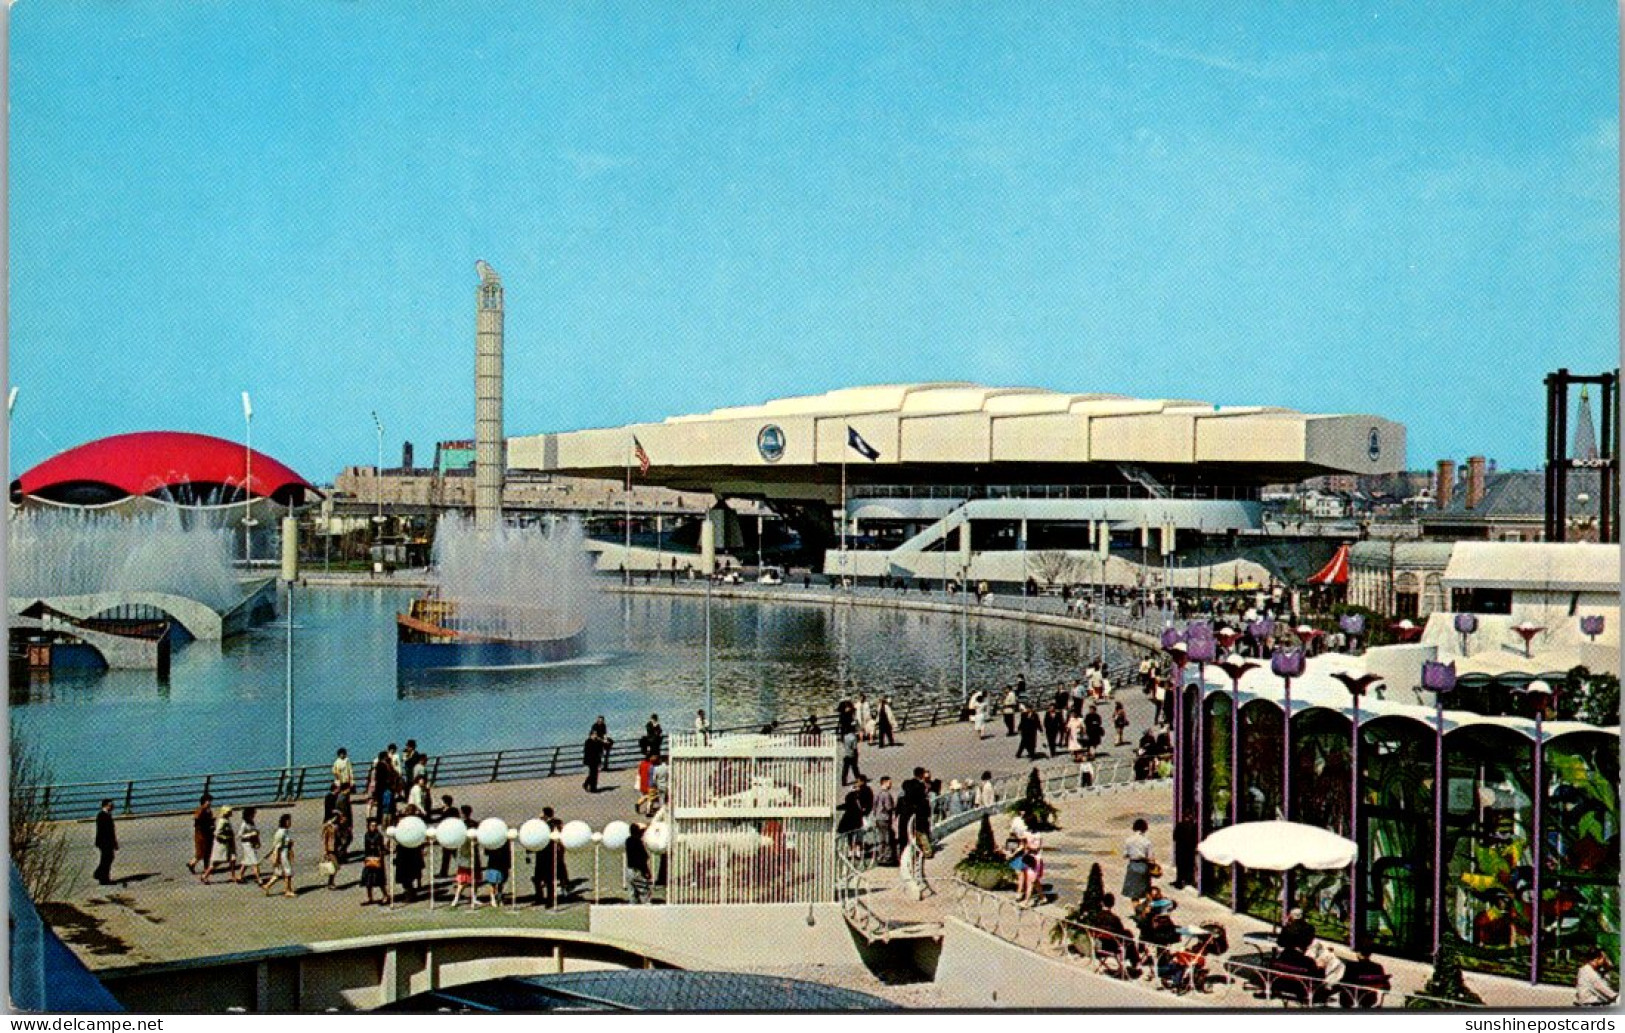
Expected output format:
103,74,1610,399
10,0,1619,481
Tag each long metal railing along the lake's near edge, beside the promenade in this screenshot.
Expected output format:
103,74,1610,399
31,666,1128,820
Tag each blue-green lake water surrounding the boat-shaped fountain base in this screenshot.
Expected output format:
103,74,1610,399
11,588,1124,783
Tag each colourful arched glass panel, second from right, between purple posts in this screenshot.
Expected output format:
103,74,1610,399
1443,724,1534,979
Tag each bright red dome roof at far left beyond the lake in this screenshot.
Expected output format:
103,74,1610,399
11,430,310,502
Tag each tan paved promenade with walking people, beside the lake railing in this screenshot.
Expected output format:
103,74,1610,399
42,685,1167,968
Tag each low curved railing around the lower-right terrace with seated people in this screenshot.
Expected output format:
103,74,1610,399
951,879,1482,1009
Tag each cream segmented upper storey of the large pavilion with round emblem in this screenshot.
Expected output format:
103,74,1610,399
509,382,1406,500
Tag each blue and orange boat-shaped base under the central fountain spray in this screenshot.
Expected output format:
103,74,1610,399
395,593,587,672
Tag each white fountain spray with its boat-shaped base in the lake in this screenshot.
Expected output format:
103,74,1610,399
395,513,592,674
